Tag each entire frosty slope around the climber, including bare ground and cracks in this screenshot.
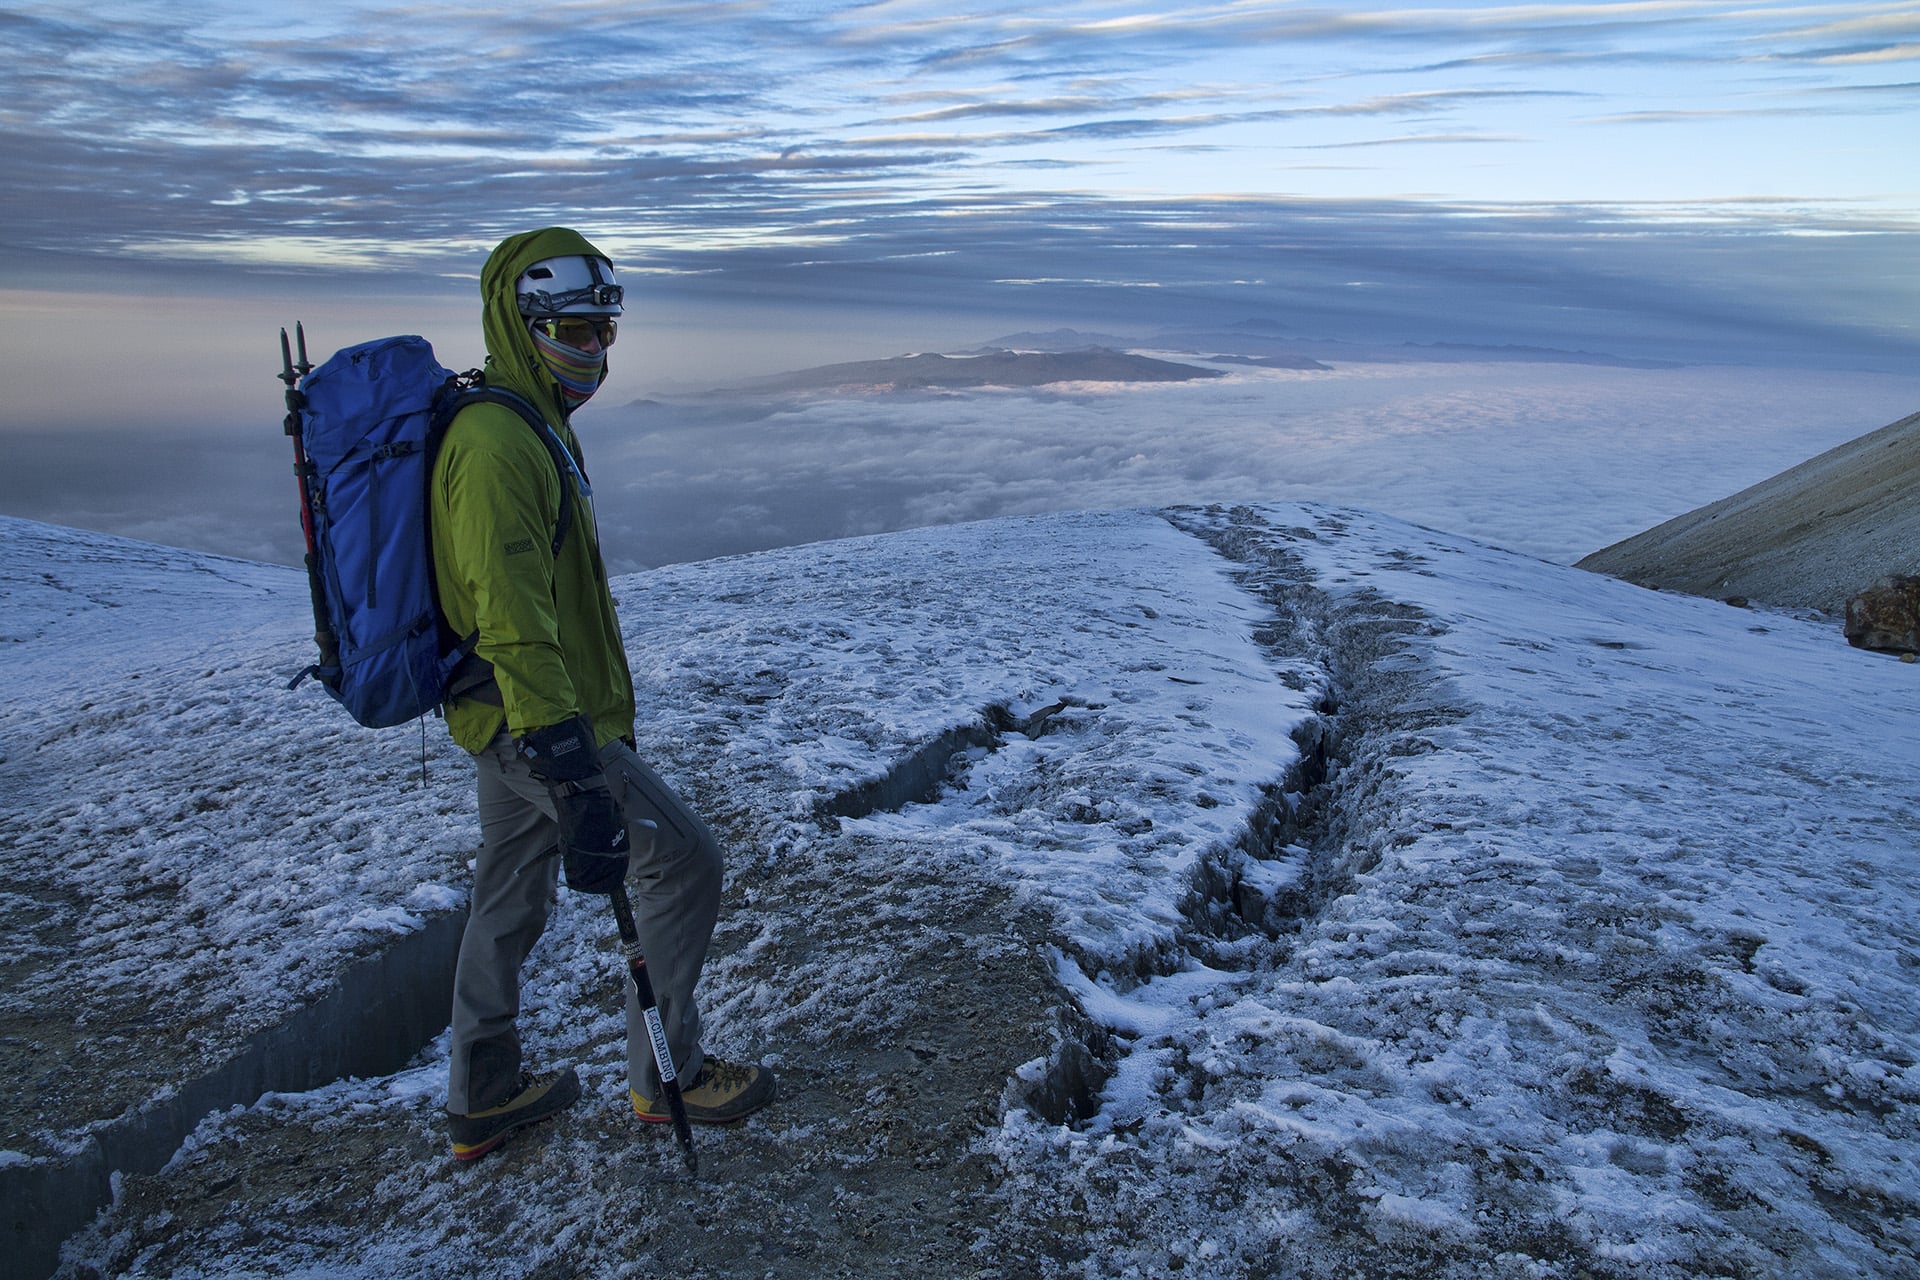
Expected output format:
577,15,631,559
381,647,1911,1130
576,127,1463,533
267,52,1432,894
0,507,1920,1276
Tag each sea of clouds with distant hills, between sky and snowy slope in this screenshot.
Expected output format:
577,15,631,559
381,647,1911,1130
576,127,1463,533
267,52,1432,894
0,357,1920,572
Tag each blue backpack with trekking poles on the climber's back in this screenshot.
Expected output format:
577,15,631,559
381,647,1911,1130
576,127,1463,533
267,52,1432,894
280,324,572,729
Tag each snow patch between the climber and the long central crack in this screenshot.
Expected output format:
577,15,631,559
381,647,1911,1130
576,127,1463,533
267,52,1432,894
622,514,1311,963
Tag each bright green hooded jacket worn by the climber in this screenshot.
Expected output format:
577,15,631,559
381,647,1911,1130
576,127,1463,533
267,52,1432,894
432,226,634,754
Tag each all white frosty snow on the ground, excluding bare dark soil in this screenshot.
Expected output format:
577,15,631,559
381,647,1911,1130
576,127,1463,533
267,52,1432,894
11,449,1920,1276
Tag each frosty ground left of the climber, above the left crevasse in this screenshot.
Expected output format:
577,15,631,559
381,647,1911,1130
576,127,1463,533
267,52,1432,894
0,518,470,1157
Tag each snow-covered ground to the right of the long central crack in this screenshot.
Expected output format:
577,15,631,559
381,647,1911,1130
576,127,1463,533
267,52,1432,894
998,509,1920,1276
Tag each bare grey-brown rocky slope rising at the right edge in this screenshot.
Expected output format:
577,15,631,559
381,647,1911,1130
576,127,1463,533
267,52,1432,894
1578,413,1920,612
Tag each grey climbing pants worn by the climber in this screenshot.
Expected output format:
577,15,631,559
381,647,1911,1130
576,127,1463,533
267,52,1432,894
447,731,722,1115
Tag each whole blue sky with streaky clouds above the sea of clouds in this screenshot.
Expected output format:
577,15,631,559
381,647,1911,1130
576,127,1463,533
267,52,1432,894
0,0,1920,564
